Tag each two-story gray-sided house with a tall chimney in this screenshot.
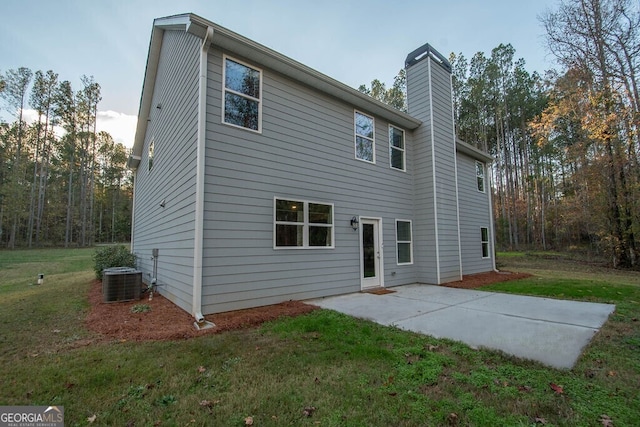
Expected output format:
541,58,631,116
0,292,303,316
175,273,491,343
129,14,495,326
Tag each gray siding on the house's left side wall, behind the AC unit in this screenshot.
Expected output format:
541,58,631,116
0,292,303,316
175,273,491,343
133,31,199,312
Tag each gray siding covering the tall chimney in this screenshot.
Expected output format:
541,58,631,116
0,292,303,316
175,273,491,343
407,57,461,284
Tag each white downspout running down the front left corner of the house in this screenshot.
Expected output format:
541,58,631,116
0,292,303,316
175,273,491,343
191,27,215,330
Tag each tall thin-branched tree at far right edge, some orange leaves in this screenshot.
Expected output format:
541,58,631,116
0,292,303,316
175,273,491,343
541,0,640,267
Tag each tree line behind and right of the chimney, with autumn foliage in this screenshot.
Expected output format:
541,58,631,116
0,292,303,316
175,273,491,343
360,0,640,267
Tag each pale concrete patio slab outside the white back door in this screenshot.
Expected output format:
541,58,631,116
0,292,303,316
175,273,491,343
306,284,615,369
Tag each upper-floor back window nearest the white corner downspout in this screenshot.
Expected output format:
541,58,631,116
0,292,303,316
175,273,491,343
223,57,262,132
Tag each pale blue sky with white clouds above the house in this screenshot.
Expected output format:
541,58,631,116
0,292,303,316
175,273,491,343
0,0,558,146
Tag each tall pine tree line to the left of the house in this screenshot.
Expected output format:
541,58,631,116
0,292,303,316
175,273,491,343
0,67,133,248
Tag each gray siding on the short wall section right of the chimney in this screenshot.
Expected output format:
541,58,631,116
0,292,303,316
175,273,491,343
458,153,493,274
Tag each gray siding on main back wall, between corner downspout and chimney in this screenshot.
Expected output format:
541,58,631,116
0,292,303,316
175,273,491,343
203,49,416,313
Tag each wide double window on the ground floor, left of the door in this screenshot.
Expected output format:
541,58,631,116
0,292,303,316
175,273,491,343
274,198,334,248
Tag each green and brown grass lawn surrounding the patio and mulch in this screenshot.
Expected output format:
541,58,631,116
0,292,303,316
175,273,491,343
0,250,640,427
